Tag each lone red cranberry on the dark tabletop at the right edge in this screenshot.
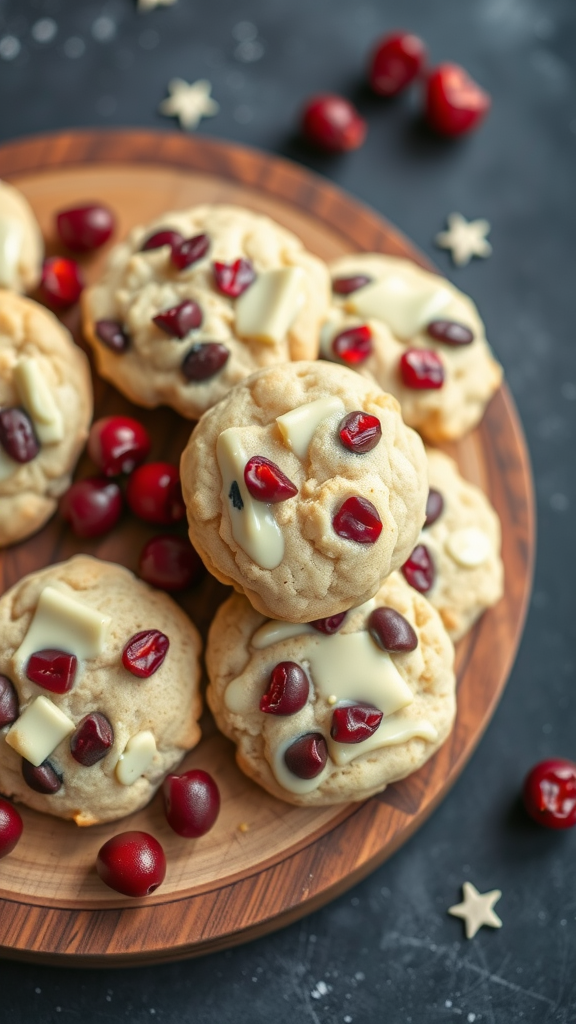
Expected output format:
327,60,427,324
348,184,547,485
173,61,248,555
523,758,576,828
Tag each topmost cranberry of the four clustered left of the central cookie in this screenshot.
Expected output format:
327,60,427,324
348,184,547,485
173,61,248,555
88,416,150,476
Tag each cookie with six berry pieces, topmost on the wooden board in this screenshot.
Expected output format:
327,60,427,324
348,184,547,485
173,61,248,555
82,206,330,420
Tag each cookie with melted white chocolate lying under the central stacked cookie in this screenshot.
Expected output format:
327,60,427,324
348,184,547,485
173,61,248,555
206,573,455,805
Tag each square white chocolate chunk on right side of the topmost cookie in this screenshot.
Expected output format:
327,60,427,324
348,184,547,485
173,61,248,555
236,266,305,345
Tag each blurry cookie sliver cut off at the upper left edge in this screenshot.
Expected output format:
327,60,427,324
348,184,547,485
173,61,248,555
0,181,44,292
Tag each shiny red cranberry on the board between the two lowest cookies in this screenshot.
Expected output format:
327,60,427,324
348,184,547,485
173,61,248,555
162,768,220,839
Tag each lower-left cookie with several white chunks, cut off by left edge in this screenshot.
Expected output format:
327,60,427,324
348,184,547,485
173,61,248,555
0,555,201,825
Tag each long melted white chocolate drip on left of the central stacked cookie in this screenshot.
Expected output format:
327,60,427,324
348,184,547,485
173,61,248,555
216,427,284,569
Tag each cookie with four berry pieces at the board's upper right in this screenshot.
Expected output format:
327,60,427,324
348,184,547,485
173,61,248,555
321,253,502,441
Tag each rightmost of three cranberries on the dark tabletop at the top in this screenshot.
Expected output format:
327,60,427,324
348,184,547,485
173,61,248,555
425,63,491,135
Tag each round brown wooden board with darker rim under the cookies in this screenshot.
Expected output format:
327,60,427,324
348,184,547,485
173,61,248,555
0,125,534,966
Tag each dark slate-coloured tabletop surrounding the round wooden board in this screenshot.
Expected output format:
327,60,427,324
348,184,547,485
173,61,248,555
0,0,576,1024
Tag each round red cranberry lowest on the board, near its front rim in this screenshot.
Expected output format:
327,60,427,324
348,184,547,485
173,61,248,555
96,831,166,897
